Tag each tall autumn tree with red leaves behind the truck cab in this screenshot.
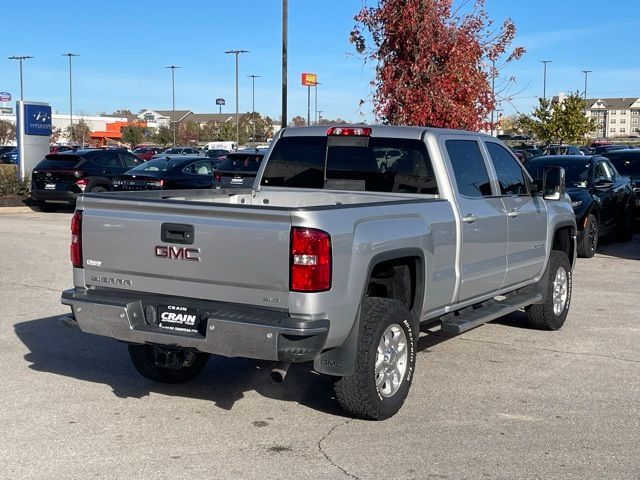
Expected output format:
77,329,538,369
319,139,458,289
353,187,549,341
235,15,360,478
350,0,524,130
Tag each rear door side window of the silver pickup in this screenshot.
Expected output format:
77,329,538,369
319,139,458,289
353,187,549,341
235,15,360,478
445,140,492,197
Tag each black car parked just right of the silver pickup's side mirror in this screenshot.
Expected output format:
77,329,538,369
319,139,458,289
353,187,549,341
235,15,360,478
525,155,635,257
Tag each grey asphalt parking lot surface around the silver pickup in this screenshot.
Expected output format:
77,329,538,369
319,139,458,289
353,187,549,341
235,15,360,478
0,212,640,480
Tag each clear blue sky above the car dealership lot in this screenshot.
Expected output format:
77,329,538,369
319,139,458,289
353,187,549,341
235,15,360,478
0,0,640,121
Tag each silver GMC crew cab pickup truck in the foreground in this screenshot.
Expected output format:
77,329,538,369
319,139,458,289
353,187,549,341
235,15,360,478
62,126,576,419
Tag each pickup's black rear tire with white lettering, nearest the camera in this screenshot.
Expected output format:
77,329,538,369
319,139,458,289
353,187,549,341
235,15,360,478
333,297,419,420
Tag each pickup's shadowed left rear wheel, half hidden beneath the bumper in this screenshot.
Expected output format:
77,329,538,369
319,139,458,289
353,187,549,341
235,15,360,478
129,345,209,383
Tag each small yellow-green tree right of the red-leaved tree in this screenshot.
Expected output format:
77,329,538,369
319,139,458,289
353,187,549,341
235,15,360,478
517,92,596,145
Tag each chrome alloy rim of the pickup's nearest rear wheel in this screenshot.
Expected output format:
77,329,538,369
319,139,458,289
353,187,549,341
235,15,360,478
375,323,408,398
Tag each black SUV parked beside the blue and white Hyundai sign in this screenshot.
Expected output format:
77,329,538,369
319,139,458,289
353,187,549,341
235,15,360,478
31,149,142,210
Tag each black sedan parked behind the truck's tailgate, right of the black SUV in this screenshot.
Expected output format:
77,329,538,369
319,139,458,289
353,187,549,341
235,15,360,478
113,156,215,190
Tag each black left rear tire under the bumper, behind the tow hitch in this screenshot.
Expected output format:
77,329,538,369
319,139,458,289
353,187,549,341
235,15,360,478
129,345,209,383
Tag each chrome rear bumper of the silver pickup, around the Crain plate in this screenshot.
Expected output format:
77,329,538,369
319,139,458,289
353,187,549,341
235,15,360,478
61,290,329,362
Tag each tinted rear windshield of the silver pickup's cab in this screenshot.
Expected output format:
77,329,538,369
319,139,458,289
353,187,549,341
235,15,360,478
262,137,438,195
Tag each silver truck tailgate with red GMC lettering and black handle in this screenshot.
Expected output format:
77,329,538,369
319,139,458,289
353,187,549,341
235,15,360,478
79,195,291,308
